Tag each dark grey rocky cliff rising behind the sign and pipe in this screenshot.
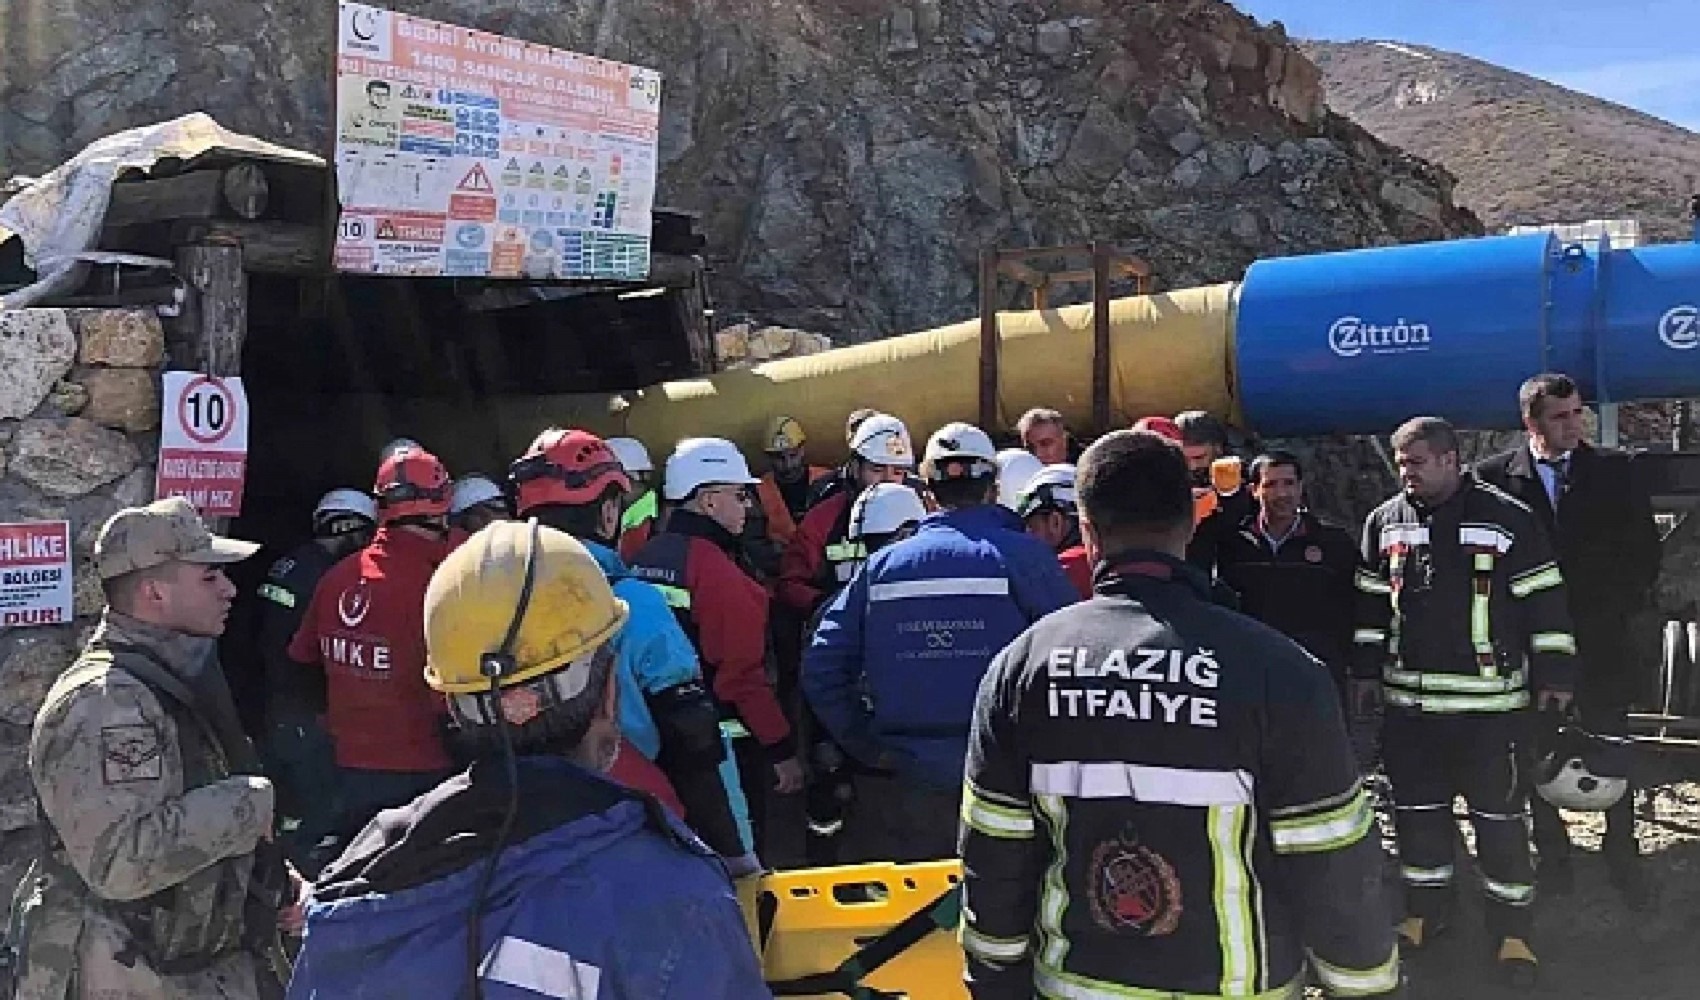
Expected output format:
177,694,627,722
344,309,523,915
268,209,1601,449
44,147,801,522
0,0,1477,338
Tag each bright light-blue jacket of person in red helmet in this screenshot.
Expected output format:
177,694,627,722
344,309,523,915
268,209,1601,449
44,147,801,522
583,541,702,760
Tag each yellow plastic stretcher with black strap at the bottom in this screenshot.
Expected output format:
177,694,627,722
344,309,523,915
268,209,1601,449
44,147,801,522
738,861,967,1000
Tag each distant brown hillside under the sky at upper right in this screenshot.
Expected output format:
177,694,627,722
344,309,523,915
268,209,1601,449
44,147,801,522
1302,41,1700,240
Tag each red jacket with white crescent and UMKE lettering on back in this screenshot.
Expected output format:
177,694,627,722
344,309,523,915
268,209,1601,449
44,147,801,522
289,527,452,772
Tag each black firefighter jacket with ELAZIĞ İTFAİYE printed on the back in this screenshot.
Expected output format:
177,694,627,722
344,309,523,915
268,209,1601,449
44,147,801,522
962,553,1399,1000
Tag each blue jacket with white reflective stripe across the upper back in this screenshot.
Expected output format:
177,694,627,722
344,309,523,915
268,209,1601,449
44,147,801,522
802,505,1080,787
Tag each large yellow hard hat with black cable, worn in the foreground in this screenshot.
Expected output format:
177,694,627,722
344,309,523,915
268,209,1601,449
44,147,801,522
425,520,629,694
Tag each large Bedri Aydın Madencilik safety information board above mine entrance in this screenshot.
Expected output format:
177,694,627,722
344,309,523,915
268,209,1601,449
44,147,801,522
335,2,661,281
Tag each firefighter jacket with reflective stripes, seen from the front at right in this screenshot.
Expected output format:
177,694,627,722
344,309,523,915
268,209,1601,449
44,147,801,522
1353,473,1576,713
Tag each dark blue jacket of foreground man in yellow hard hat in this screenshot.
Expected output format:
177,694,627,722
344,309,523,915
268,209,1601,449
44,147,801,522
289,757,772,1000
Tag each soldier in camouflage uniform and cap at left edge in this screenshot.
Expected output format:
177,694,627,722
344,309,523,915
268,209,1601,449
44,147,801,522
7,498,299,1000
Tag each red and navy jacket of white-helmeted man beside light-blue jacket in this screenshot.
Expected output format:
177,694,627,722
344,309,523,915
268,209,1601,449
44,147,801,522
631,510,797,762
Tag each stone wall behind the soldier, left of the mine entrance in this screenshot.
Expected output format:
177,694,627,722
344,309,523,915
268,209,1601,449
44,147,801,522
0,310,165,905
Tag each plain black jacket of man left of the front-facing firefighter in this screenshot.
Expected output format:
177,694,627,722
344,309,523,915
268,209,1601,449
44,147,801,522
1216,512,1358,680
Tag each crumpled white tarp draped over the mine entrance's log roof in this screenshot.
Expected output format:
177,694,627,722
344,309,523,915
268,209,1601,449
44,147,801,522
0,112,325,310
